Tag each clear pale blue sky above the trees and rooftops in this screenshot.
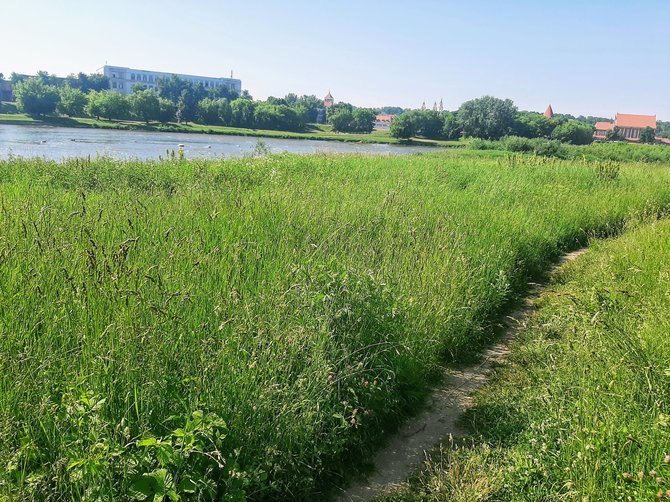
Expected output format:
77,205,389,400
5,0,670,120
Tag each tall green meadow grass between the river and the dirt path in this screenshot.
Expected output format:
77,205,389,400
0,151,670,500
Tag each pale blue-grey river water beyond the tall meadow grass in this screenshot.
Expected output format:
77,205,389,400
0,125,440,160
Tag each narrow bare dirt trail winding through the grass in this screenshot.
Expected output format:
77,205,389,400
336,248,587,502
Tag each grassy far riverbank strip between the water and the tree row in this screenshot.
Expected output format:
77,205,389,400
0,114,463,148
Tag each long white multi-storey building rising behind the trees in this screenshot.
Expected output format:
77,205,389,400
102,65,242,95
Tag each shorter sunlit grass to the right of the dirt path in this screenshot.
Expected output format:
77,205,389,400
384,220,670,501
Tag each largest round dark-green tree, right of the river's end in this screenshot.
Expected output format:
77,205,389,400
458,96,517,139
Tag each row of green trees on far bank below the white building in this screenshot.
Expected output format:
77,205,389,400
5,72,375,132
